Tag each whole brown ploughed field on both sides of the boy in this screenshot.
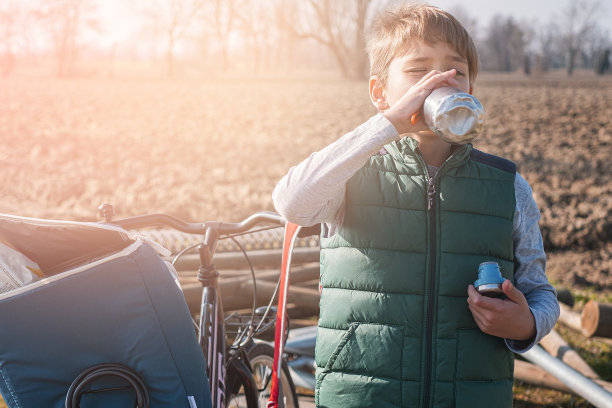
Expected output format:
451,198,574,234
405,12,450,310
0,71,612,291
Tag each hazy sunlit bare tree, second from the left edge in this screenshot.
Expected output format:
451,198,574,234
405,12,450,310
38,0,99,77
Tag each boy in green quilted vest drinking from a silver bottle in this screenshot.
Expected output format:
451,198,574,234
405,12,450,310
273,4,559,408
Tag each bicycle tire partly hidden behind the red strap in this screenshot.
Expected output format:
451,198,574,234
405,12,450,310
247,343,299,408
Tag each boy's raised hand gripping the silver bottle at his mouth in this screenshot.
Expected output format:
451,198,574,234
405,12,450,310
383,69,460,134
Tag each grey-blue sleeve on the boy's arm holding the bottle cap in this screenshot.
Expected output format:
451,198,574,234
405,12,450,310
505,173,559,353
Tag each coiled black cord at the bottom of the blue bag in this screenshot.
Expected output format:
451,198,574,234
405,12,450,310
65,363,149,408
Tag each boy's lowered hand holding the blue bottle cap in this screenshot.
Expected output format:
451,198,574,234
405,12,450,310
468,279,536,340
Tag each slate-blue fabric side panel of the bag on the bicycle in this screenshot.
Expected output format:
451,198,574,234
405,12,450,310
0,245,211,408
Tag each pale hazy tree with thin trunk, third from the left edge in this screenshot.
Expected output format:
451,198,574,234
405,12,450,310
141,0,204,78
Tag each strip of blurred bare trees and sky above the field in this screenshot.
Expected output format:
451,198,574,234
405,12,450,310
0,0,612,78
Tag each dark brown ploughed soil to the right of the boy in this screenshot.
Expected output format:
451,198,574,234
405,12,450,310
476,78,612,291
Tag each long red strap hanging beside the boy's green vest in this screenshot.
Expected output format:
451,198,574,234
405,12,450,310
267,222,302,408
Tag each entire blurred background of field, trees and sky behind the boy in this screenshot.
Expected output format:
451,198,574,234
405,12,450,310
0,0,612,407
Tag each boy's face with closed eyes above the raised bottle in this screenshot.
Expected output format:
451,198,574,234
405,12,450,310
383,40,472,107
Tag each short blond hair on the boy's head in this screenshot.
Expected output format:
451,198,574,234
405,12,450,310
367,3,478,85
